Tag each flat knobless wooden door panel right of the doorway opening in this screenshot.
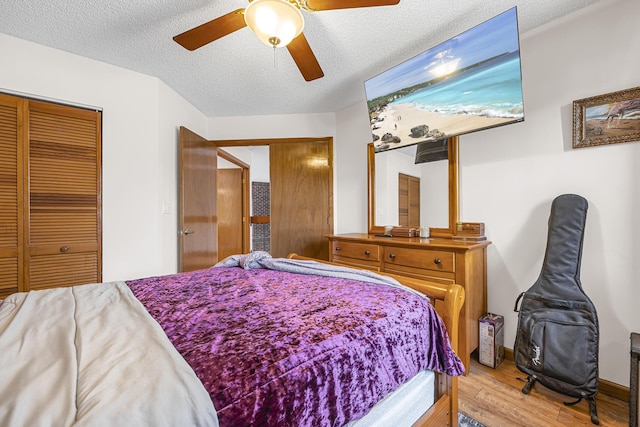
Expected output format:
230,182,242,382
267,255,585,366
269,140,333,260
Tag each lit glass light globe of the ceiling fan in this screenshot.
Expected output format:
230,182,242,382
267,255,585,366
244,0,304,47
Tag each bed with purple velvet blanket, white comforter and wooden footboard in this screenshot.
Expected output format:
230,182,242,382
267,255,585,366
0,254,464,427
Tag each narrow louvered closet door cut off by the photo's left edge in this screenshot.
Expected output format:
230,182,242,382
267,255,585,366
0,94,25,298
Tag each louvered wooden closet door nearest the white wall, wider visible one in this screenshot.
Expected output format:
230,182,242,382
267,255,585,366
25,101,102,290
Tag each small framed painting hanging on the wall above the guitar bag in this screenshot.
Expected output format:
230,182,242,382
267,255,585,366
573,86,640,148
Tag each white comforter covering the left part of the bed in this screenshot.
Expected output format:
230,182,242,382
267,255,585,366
0,282,218,427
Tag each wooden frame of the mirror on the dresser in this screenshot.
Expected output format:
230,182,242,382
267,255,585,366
367,136,460,239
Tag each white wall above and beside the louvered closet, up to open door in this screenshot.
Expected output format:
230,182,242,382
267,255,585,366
0,34,206,281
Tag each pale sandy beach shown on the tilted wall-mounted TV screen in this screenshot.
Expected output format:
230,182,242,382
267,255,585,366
372,104,512,147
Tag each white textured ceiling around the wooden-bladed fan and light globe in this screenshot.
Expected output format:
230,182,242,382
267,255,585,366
0,0,598,116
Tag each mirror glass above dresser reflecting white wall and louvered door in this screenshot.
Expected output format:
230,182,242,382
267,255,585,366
375,145,449,228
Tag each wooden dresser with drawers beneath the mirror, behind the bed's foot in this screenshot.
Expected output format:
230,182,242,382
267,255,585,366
327,233,491,372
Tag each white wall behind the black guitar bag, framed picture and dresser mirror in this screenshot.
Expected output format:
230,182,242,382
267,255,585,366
336,0,640,386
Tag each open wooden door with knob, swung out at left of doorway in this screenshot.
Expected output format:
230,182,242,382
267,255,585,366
179,127,218,271
